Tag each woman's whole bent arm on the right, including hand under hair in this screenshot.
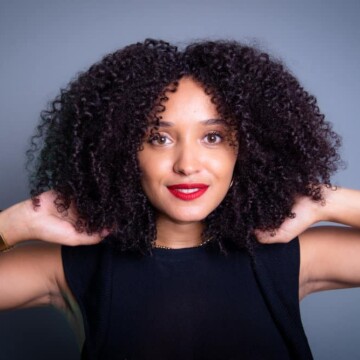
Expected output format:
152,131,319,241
256,187,360,298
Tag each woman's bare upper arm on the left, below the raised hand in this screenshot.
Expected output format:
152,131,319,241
0,242,68,310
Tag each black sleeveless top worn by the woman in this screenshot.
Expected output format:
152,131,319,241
62,240,311,360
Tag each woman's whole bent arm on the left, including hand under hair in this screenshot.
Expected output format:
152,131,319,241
0,192,106,310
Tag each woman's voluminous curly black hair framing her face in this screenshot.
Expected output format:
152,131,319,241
28,39,340,253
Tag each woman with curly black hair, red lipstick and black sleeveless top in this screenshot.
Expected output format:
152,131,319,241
0,40,360,359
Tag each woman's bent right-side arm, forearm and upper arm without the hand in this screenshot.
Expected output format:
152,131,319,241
300,188,360,297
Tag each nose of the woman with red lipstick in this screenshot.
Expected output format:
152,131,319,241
173,144,201,176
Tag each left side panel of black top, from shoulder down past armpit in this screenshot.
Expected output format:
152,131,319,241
62,244,112,360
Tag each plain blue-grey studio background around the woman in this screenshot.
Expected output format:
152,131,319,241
0,0,360,360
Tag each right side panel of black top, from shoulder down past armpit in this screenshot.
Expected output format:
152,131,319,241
252,238,313,360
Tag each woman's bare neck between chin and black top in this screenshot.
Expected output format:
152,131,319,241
156,216,204,249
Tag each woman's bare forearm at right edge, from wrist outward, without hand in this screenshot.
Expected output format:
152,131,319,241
319,187,360,228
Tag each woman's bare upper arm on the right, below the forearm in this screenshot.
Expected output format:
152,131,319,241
299,226,360,298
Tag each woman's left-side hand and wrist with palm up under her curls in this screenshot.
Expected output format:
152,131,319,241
0,191,109,245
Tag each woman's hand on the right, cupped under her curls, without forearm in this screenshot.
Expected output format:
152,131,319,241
255,196,324,244
